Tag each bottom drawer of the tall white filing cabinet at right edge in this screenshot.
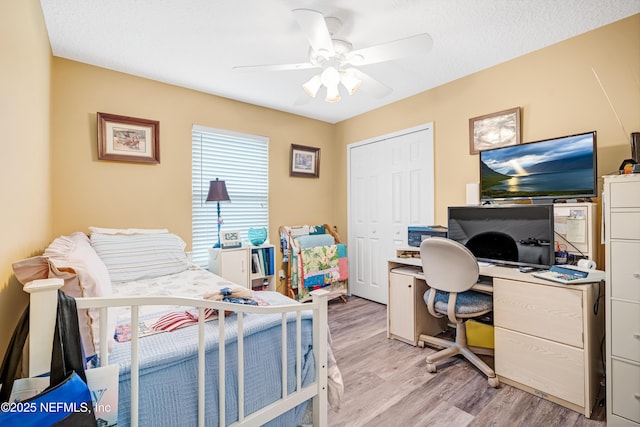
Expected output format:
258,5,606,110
607,359,640,423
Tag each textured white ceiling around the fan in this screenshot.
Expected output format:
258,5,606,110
41,0,640,123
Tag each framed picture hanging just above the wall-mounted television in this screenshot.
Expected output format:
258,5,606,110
469,107,520,154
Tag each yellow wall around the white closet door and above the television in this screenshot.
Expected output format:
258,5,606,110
336,14,640,232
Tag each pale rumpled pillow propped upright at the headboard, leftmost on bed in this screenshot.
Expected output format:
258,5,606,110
13,232,117,357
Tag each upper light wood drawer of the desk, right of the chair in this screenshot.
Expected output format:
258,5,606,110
493,279,584,348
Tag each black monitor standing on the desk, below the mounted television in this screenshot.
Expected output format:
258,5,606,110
448,204,555,269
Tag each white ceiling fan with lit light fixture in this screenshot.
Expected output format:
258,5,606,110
233,9,433,102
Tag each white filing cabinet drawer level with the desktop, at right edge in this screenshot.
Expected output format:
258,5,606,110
607,240,640,302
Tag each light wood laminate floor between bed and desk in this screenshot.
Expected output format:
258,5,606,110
329,297,606,427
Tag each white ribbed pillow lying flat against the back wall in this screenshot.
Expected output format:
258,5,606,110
91,233,189,283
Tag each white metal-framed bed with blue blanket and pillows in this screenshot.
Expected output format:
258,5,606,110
14,229,342,426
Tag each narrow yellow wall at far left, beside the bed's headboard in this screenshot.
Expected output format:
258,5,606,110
0,0,52,357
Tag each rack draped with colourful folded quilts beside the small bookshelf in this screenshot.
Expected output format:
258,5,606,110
280,224,349,302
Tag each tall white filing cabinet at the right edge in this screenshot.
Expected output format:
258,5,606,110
603,175,640,426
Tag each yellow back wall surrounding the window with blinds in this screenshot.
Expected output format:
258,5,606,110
51,58,337,276
